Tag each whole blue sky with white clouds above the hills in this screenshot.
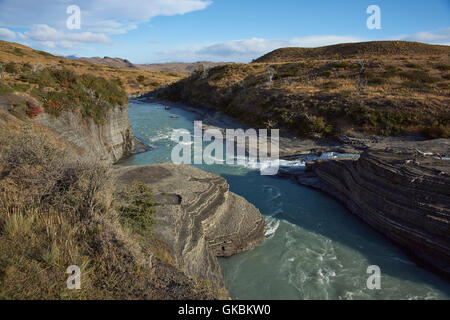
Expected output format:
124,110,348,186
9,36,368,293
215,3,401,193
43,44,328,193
0,0,450,63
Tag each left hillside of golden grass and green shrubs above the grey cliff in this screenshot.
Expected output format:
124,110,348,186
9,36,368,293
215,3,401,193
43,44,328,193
0,41,186,123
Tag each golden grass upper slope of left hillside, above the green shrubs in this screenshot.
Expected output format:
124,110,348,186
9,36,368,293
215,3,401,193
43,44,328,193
0,41,184,95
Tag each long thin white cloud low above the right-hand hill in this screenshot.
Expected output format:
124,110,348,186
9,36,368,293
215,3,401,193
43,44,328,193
160,35,362,62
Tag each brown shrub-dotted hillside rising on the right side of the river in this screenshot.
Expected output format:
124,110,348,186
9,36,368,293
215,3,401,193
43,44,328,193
160,41,450,138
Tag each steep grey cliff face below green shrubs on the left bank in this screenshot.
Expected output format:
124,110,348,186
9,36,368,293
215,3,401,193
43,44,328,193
36,107,135,163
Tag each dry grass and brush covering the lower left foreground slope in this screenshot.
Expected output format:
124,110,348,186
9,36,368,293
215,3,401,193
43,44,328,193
0,127,212,299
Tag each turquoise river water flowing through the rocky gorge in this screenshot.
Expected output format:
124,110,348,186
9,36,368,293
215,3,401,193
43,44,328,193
121,101,450,299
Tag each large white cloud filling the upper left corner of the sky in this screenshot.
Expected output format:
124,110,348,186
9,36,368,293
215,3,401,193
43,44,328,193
0,0,211,49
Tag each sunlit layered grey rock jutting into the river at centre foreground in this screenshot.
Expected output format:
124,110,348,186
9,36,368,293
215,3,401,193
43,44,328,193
115,163,265,288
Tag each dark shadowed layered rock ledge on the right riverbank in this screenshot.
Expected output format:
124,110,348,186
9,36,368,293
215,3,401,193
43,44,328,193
297,139,450,275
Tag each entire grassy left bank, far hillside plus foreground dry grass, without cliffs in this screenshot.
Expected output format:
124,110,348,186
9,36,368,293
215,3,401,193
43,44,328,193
0,42,226,300
